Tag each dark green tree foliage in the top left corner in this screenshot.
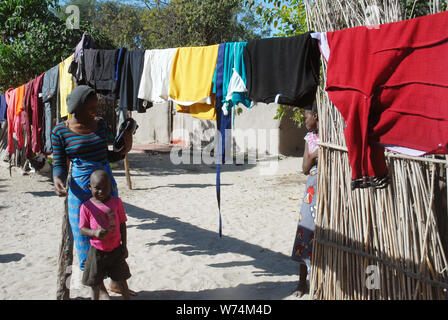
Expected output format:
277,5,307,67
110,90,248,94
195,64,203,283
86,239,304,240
0,0,114,91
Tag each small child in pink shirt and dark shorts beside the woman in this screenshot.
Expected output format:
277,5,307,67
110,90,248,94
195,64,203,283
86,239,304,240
79,170,131,300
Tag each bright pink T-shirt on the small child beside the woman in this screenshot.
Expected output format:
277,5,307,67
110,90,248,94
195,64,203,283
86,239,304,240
79,197,127,252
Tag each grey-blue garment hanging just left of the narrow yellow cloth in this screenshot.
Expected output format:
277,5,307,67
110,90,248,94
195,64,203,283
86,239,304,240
41,66,59,154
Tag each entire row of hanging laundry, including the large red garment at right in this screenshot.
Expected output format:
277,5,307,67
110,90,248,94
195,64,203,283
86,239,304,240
0,11,448,195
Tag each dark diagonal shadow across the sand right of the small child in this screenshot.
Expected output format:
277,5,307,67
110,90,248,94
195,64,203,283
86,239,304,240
121,203,298,300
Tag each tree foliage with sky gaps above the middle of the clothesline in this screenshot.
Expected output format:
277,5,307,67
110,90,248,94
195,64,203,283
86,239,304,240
61,0,270,49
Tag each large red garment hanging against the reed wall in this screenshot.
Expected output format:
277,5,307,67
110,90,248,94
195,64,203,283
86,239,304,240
320,12,448,189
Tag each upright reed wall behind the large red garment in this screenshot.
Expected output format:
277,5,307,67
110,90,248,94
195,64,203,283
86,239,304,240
305,0,448,299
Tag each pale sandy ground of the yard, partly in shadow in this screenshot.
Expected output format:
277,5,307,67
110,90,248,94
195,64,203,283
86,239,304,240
0,152,308,300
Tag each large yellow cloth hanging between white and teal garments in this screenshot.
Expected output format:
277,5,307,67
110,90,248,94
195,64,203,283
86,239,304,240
169,45,219,120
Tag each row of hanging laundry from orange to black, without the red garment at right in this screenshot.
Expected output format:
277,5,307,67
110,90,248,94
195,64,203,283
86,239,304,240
0,33,319,156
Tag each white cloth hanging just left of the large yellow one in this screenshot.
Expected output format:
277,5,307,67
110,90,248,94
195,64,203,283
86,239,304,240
138,48,177,103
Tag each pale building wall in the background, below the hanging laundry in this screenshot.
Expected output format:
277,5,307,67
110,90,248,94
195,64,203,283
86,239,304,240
132,103,306,156
